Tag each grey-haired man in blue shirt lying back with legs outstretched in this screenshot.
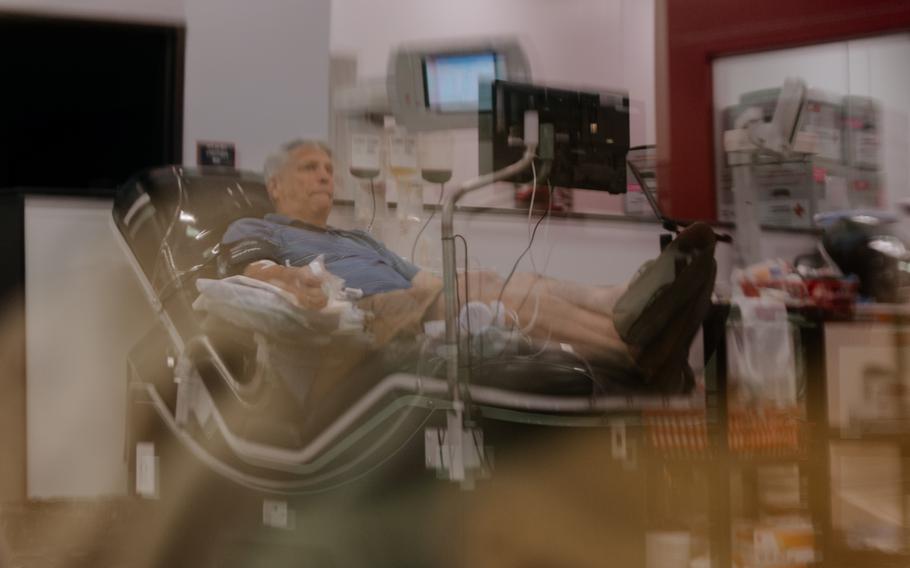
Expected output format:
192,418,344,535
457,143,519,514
222,140,716,391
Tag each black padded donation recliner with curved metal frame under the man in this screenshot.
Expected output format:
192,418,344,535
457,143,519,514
113,166,697,493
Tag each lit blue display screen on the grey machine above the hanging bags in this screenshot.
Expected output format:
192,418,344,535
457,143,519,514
423,51,504,112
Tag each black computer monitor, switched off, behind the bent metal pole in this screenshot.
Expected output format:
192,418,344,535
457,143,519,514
478,80,629,193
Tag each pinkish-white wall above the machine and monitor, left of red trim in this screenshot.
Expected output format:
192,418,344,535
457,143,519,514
330,0,656,144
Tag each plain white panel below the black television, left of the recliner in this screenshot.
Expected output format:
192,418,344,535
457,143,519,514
25,197,153,498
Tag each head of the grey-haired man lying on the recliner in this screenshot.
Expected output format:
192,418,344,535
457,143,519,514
268,146,335,225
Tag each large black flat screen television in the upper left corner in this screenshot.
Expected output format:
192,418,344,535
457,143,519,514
0,15,184,193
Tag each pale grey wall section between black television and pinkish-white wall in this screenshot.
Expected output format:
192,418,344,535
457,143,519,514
183,0,330,170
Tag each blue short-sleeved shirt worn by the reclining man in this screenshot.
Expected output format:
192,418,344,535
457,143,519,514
221,213,420,296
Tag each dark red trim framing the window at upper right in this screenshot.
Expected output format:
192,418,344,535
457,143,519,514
656,0,910,219
